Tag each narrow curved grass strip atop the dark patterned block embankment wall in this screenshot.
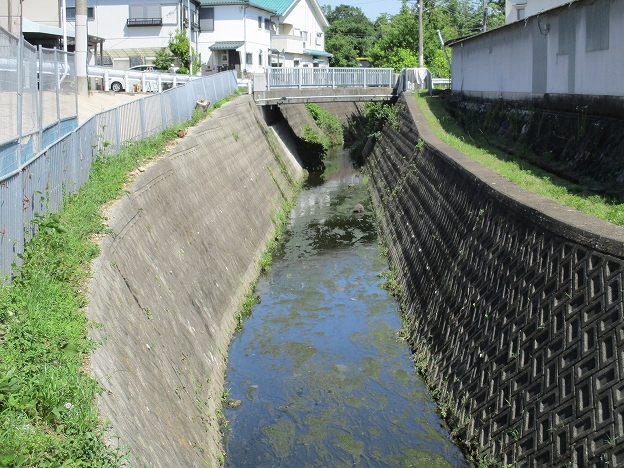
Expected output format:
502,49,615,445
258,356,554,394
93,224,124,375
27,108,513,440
416,92,624,226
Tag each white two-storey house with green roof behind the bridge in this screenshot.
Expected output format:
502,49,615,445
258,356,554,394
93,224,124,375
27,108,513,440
197,0,331,73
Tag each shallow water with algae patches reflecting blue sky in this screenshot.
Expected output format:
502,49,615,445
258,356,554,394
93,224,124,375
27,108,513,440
225,148,469,468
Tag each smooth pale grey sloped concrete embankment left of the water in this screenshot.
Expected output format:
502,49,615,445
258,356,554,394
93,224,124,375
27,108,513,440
88,97,301,467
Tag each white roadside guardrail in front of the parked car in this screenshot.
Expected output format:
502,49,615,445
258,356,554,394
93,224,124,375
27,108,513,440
88,66,195,93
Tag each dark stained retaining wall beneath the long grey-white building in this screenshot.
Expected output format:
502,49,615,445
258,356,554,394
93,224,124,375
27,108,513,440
447,95,624,198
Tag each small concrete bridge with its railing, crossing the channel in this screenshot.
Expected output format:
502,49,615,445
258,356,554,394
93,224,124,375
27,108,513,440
250,67,398,106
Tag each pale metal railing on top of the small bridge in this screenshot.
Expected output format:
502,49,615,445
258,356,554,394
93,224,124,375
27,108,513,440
266,67,395,90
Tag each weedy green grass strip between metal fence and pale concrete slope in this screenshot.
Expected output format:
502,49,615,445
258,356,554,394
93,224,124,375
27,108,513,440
0,93,239,467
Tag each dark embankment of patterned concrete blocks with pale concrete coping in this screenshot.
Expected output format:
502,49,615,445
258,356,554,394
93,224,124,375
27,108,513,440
367,95,624,467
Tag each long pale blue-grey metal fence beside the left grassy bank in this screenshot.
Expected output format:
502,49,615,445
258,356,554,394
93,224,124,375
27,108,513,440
0,72,238,276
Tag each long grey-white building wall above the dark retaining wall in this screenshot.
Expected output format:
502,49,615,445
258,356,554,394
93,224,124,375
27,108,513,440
452,0,624,99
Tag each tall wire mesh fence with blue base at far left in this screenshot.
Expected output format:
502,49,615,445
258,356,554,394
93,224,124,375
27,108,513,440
0,28,78,177
